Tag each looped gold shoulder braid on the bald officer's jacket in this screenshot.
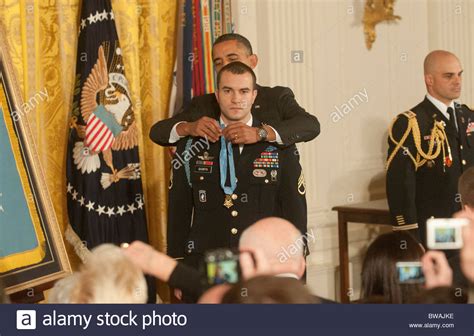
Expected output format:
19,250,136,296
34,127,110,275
385,111,452,170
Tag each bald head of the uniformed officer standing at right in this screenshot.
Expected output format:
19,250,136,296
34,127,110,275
423,50,462,105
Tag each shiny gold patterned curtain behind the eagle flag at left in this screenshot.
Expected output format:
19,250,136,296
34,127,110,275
0,0,178,276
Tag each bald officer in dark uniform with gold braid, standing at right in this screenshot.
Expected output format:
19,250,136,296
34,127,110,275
386,50,474,286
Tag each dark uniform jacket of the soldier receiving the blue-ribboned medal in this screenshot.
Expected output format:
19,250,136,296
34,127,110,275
167,118,307,258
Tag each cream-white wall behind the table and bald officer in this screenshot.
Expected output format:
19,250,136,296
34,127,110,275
232,0,474,299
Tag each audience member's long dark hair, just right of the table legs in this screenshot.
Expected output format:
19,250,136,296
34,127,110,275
361,232,424,303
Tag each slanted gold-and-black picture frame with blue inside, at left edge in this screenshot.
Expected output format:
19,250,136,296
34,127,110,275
0,26,71,294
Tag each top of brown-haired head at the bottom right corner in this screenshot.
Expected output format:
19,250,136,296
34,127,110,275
408,287,467,304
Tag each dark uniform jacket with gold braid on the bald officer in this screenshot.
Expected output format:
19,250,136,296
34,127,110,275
386,98,474,243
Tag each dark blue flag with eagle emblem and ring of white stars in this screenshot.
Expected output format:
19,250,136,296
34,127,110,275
66,0,148,270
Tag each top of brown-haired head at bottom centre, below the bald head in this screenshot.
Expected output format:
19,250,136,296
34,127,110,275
222,276,319,304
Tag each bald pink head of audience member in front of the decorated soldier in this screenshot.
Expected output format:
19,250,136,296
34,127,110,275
239,217,306,278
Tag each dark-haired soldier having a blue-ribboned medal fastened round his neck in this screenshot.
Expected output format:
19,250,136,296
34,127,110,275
168,62,307,267
